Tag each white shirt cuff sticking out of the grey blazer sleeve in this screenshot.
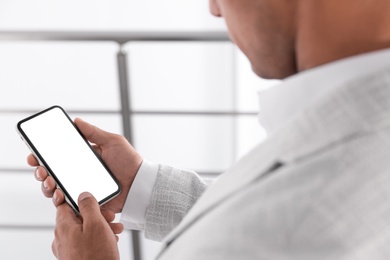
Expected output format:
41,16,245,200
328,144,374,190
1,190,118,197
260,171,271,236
120,160,159,230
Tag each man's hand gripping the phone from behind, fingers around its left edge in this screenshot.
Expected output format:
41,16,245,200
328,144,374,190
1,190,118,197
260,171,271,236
27,118,142,213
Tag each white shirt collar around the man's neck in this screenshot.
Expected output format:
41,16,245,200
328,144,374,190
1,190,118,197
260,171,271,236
259,49,390,133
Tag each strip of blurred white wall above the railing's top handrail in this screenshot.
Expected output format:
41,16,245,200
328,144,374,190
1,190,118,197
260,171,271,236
0,0,224,30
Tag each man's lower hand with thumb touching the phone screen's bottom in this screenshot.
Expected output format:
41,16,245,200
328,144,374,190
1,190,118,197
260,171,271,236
52,192,123,260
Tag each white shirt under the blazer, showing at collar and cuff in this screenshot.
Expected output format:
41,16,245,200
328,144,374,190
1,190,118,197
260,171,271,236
121,49,390,230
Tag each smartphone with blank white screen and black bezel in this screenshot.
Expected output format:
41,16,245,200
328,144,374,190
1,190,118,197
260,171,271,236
17,106,121,213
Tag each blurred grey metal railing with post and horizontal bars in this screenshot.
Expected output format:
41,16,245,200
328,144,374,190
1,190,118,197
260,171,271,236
0,31,238,260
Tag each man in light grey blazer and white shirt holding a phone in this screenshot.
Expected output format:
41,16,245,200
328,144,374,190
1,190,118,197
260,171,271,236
28,0,390,260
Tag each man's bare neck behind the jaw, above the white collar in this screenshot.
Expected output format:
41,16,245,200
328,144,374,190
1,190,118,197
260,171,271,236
296,0,390,71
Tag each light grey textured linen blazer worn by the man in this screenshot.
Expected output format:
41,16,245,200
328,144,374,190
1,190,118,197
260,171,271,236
145,68,390,260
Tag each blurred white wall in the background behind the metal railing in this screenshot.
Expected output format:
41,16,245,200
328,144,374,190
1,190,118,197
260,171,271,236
0,0,269,260
